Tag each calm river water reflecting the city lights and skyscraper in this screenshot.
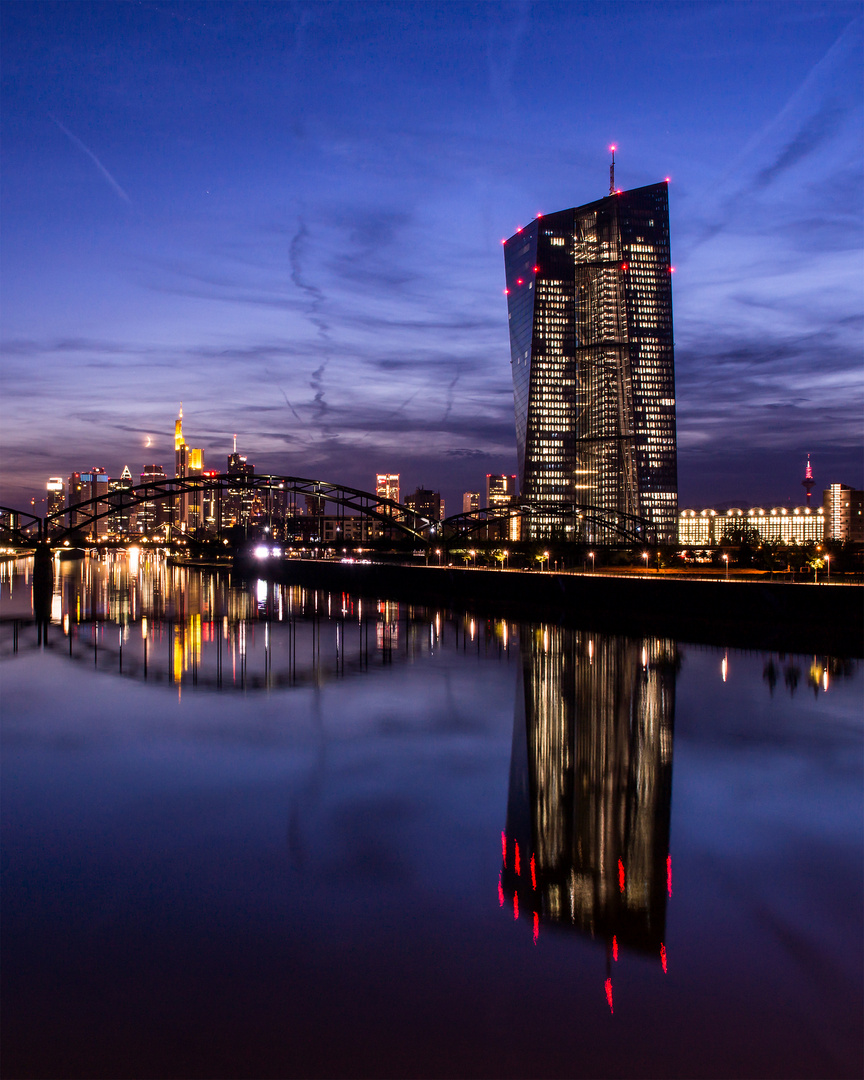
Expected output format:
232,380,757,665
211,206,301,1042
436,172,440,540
0,553,864,1078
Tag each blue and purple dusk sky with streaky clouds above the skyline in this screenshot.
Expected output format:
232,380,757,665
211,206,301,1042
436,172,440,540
0,0,864,512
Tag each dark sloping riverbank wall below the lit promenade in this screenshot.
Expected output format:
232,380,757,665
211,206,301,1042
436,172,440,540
237,559,864,657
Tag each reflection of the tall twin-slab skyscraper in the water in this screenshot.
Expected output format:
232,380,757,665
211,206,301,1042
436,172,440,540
501,626,677,956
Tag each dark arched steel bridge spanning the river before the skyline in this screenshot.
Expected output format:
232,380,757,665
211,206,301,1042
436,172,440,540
0,473,651,546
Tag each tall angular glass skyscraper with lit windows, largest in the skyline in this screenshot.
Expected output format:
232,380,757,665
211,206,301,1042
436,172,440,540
504,183,678,543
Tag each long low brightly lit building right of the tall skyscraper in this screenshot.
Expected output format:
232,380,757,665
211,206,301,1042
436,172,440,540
678,507,825,548
